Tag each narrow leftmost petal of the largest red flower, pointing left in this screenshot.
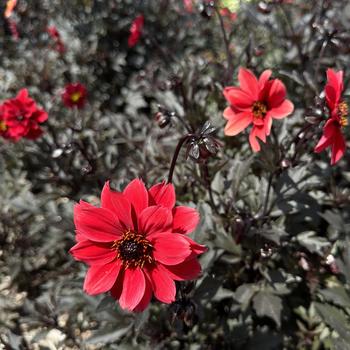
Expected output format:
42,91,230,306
69,241,117,265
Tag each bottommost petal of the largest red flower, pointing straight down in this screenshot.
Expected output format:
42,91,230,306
119,267,146,311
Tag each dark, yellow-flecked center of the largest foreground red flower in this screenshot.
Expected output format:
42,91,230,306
112,230,154,268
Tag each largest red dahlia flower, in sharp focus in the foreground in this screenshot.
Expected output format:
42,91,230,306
70,179,206,311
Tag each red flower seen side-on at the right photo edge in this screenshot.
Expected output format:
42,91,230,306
315,69,348,165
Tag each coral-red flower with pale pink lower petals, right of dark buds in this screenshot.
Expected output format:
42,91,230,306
224,68,294,152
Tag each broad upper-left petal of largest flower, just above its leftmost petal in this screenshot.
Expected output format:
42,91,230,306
74,201,123,242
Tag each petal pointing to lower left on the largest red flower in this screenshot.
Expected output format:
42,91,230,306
84,260,121,295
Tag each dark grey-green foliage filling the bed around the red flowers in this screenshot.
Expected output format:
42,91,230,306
0,0,350,350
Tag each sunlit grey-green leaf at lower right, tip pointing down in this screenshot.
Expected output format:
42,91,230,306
253,292,282,327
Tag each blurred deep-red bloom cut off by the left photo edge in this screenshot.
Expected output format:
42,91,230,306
0,89,48,141
